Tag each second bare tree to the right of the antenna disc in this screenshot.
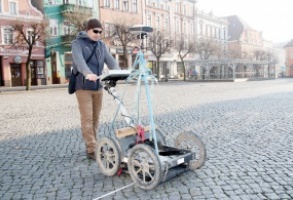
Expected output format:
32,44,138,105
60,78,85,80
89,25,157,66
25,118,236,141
176,35,196,81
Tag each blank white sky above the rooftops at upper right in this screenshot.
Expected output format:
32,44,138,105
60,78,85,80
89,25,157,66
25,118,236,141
197,0,293,43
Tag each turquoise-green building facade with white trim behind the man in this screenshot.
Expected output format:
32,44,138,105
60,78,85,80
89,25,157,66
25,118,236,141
44,0,99,84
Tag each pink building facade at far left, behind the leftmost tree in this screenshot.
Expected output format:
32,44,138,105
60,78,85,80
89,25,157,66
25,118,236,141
0,0,46,87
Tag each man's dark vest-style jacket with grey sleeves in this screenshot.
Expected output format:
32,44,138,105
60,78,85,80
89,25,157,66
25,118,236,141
71,31,120,90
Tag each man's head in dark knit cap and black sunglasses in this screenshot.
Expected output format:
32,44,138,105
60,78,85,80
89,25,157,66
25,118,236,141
85,19,103,41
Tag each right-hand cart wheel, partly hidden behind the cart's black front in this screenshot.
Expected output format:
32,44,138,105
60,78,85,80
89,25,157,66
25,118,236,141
175,132,206,170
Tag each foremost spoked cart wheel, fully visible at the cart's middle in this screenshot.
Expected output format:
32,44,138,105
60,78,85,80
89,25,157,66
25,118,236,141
128,144,161,190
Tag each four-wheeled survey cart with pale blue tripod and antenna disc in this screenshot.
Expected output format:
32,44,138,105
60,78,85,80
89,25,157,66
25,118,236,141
96,26,206,190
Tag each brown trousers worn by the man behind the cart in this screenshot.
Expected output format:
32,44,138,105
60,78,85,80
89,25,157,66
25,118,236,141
75,89,103,153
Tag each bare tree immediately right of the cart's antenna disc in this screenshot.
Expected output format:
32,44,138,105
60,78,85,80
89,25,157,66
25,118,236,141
149,30,173,77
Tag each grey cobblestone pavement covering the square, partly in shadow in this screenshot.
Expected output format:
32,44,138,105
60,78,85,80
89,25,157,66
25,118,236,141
0,79,293,200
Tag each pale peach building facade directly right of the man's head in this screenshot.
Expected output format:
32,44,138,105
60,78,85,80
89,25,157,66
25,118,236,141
99,0,144,68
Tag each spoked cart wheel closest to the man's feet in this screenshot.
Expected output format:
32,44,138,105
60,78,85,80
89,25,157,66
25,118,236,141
96,137,121,176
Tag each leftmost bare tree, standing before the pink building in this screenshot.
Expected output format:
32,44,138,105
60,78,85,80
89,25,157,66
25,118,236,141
11,20,48,90
